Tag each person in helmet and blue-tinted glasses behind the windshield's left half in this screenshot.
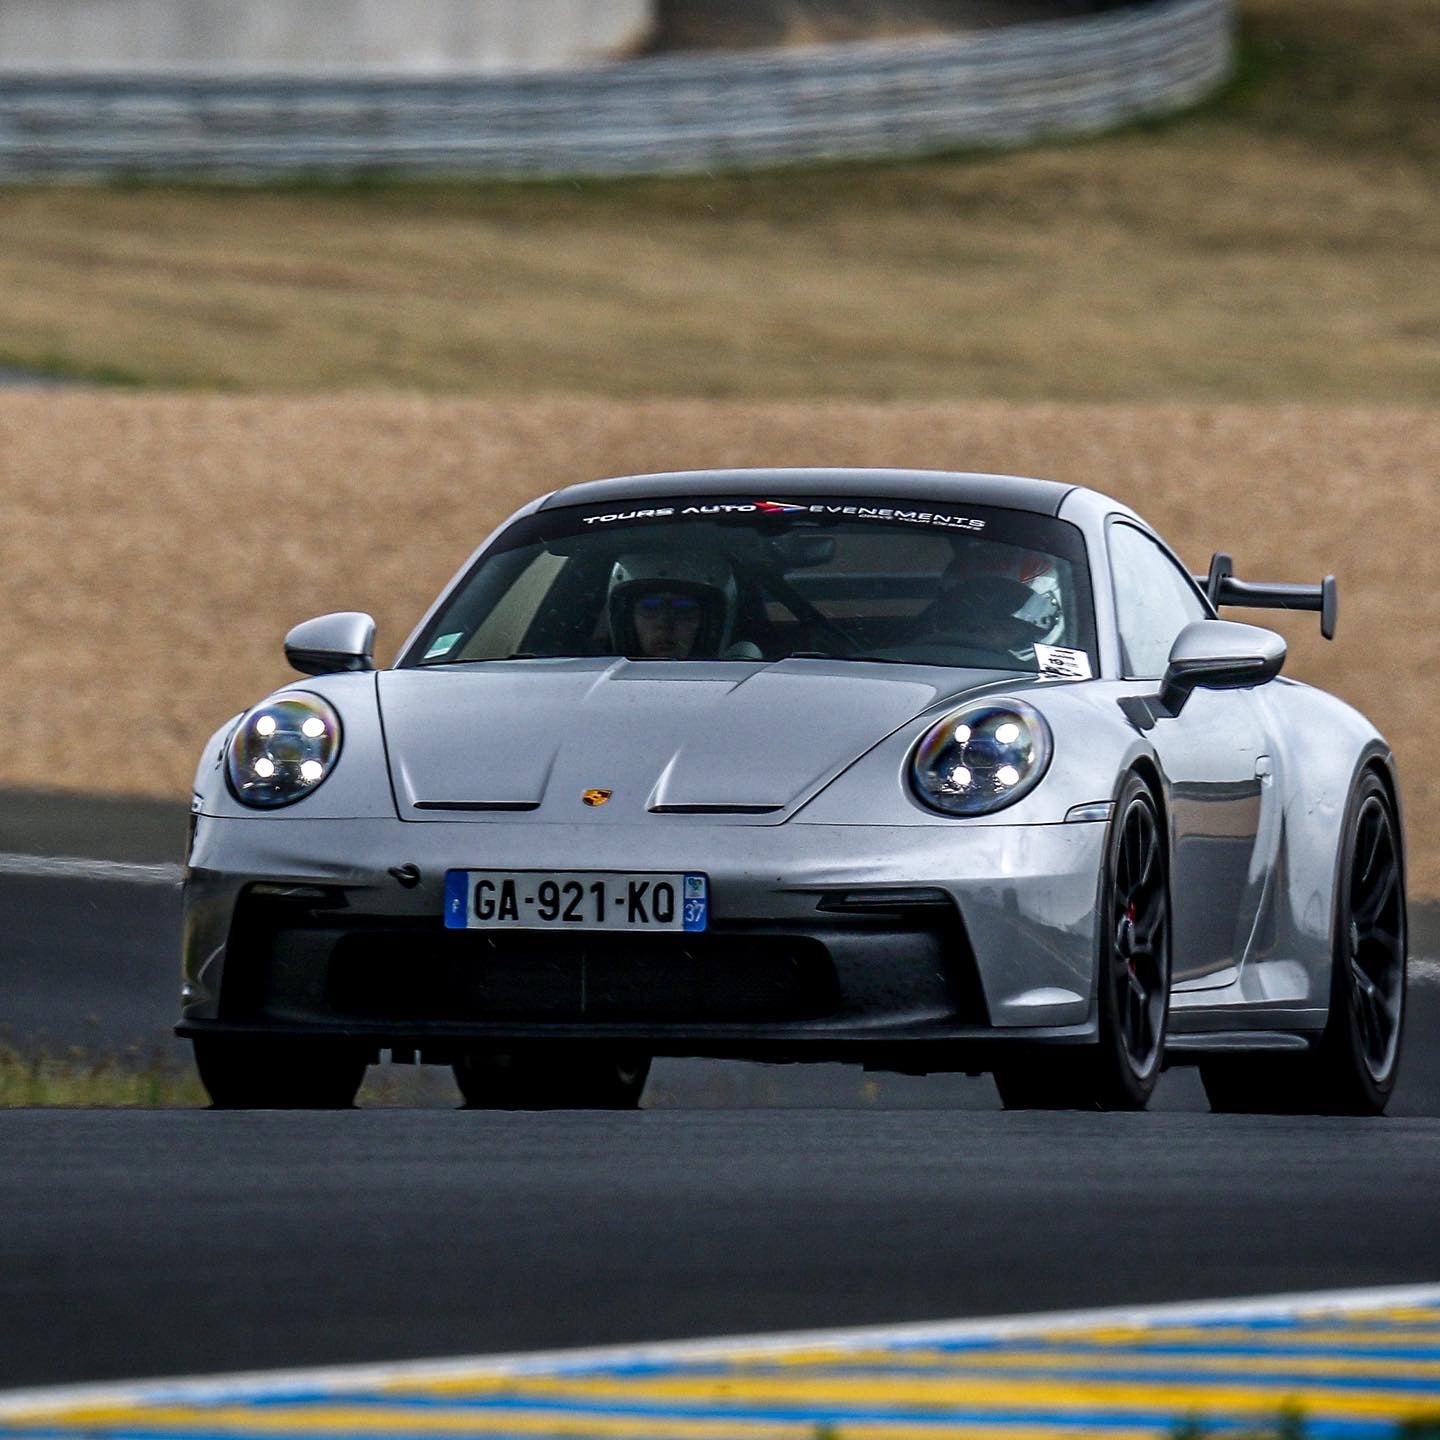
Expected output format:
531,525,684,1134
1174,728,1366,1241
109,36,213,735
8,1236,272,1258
606,552,737,660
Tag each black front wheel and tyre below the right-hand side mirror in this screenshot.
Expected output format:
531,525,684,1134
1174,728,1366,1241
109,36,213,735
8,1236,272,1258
995,775,1171,1110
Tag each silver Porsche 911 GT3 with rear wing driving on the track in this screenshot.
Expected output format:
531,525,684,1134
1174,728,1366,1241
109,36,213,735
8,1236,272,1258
179,469,1405,1112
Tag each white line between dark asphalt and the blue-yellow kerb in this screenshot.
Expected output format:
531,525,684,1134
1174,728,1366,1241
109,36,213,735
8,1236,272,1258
0,1283,1440,1420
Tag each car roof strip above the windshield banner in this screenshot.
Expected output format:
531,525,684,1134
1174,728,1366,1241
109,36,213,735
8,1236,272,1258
540,469,1077,516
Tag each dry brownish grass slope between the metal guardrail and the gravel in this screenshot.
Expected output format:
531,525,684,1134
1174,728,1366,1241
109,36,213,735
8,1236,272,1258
0,0,1440,403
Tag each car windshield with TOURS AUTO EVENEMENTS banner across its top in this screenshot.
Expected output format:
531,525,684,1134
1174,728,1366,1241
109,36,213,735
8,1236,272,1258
402,497,1094,677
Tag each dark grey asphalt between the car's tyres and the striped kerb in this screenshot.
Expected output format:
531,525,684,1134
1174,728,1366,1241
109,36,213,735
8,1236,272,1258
0,1110,1440,1388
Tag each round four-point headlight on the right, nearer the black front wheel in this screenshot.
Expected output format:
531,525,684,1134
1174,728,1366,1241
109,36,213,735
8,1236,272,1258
910,700,1053,815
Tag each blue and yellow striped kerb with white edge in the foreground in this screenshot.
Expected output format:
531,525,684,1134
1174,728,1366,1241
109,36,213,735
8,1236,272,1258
0,1286,1440,1440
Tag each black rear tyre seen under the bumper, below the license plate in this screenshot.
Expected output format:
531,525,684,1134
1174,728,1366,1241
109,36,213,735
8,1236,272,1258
454,1048,649,1110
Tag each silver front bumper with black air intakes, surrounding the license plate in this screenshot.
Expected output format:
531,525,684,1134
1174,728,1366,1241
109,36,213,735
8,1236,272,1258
179,815,1104,1068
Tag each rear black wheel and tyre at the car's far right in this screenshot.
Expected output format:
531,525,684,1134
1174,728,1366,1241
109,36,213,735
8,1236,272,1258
1200,770,1407,1115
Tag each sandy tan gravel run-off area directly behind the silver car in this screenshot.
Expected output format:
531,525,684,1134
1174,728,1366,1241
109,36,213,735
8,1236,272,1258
0,392,1440,897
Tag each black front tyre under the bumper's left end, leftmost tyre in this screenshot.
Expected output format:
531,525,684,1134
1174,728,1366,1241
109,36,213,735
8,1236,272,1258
193,1035,369,1110
